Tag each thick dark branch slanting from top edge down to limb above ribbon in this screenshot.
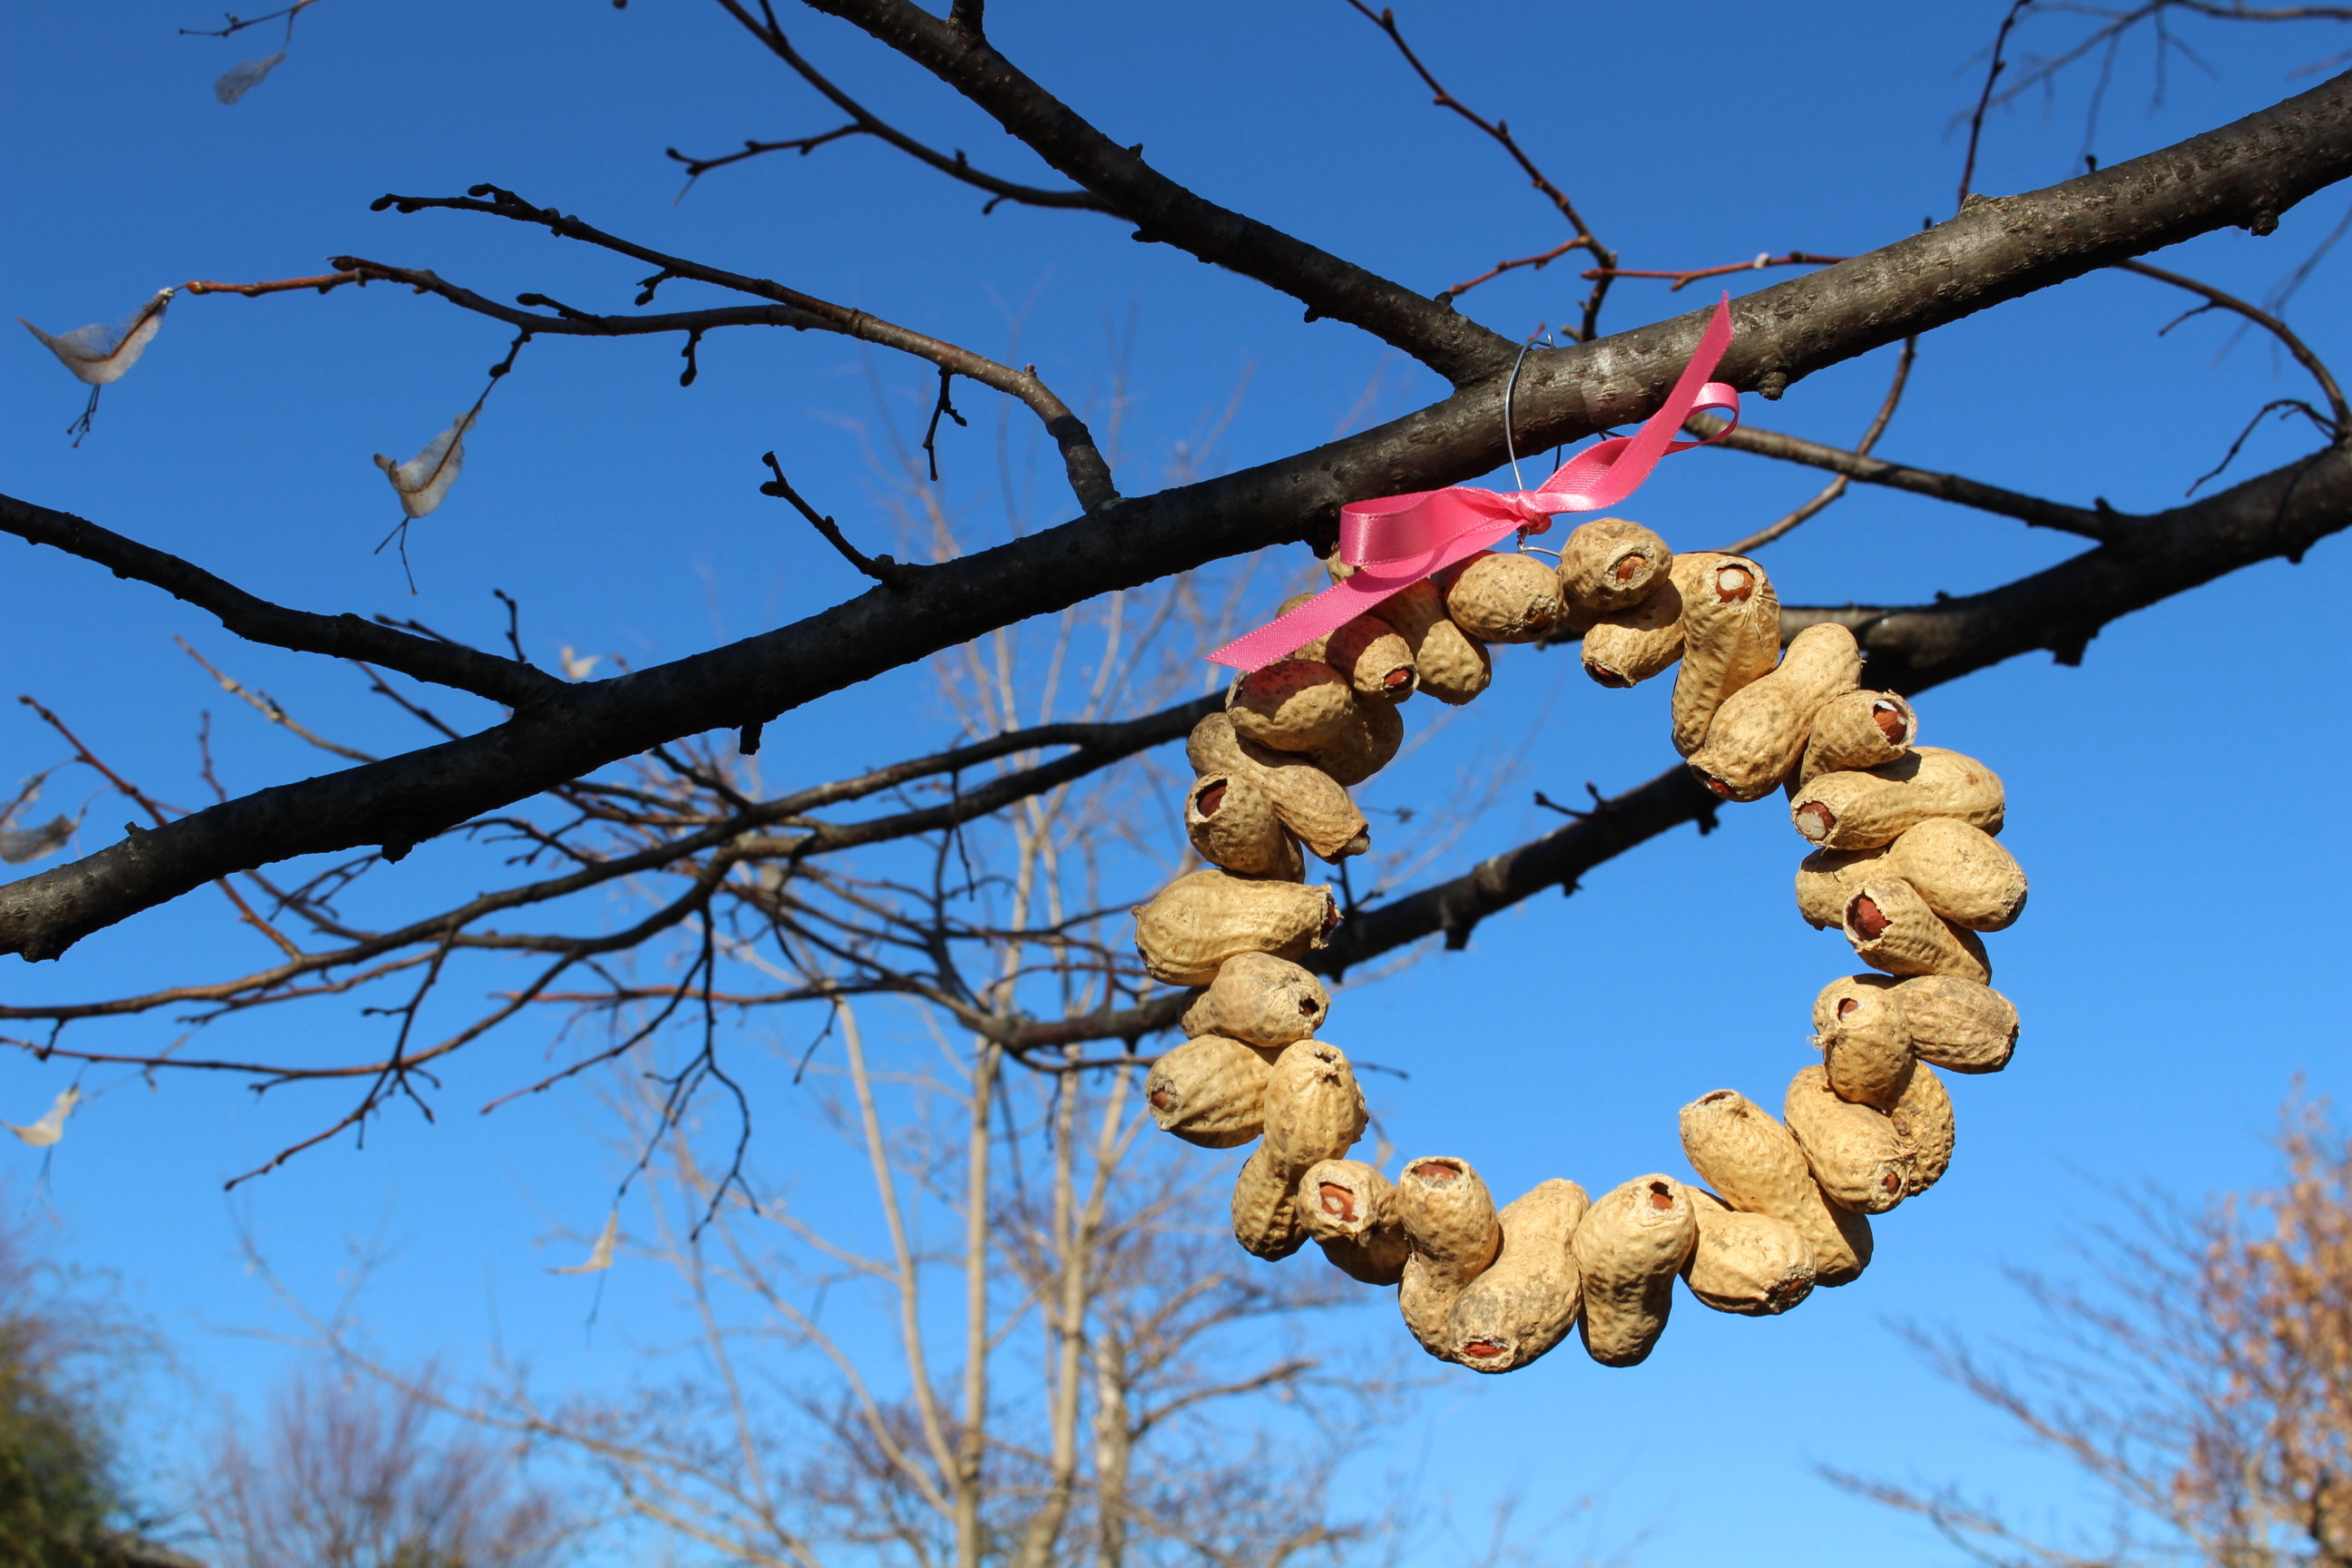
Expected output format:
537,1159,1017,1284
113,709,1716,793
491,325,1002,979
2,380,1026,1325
771,0,1517,386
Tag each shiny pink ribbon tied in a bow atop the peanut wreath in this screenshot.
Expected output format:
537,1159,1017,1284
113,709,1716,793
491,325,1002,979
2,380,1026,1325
1209,294,1740,670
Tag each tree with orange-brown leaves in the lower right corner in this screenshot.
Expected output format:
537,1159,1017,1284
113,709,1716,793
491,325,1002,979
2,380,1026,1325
1832,1105,2352,1568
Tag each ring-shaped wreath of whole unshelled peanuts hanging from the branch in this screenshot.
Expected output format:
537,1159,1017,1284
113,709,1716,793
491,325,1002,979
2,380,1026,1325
1136,517,2025,1373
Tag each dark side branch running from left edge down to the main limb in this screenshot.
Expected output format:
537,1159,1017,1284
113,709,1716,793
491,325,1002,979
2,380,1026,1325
0,496,564,710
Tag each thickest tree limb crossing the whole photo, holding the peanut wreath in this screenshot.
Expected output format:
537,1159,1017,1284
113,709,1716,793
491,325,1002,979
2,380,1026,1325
0,76,2352,956
